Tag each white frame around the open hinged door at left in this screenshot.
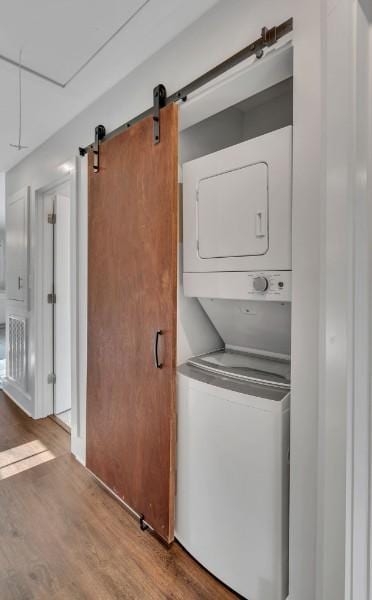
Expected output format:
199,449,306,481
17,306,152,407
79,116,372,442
34,158,79,430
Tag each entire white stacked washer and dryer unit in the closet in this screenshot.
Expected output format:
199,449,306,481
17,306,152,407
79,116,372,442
176,127,292,600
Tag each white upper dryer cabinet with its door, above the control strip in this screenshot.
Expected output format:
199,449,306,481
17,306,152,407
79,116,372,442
183,126,292,274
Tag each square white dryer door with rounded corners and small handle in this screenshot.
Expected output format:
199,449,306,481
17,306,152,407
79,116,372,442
197,162,269,260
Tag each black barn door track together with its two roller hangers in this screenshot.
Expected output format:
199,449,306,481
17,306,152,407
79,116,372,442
79,18,293,173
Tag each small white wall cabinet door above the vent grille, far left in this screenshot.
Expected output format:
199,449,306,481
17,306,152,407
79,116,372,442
6,187,29,302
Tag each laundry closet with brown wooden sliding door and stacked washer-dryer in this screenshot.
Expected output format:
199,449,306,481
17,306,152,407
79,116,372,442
87,24,293,600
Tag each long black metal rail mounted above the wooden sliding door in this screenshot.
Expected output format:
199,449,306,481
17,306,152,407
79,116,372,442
79,18,293,159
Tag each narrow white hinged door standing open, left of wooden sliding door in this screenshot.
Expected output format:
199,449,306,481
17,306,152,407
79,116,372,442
54,194,71,415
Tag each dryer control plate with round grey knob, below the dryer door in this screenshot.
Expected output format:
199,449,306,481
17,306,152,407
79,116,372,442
247,271,291,301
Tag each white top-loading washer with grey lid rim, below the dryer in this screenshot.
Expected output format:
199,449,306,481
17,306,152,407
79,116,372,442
176,350,289,600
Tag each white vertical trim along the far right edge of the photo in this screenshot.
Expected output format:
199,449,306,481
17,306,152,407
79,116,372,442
345,2,372,600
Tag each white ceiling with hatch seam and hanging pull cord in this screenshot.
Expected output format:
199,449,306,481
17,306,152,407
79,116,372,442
0,0,217,171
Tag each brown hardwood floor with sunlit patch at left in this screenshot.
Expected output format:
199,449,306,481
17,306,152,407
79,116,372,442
0,392,237,600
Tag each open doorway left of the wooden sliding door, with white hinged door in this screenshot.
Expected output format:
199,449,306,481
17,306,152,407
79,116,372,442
36,177,73,432
